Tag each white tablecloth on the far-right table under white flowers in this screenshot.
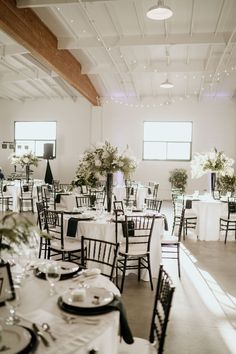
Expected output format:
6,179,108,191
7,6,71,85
186,195,228,241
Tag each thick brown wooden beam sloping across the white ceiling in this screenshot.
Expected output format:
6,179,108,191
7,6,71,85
0,0,99,106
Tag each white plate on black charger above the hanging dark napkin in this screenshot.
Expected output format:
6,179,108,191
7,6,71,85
62,287,114,308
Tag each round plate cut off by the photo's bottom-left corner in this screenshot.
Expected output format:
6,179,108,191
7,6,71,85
0,325,32,354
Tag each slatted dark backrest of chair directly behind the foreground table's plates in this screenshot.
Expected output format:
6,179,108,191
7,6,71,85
81,236,119,280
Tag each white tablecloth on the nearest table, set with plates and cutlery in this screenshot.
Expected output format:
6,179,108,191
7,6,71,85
0,268,119,354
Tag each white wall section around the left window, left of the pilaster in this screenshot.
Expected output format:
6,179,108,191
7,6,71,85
0,98,91,183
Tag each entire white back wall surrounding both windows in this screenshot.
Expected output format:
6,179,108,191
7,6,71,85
0,98,236,198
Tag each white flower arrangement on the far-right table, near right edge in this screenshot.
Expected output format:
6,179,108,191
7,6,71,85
191,148,234,191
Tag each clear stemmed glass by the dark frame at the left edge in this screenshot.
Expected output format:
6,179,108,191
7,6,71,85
5,285,21,325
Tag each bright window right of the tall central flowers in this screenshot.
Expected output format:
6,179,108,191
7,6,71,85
143,122,192,160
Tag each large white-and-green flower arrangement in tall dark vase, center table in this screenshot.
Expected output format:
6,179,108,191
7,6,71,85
72,141,137,211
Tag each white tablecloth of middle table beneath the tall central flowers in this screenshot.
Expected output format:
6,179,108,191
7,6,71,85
64,215,164,281
